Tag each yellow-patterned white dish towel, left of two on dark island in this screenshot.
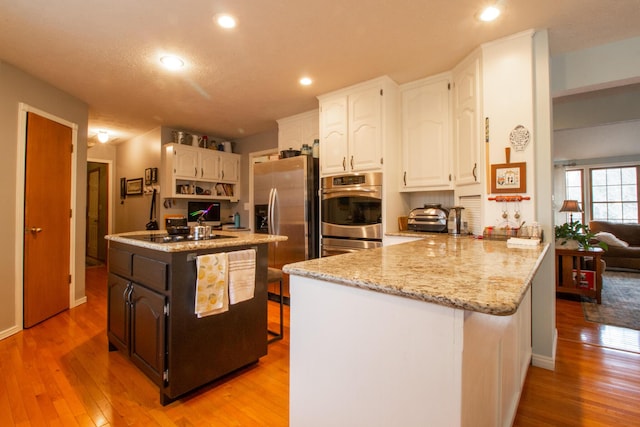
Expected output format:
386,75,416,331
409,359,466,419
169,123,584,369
195,252,229,317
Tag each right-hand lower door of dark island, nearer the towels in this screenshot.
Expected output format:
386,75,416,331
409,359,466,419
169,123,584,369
130,283,167,385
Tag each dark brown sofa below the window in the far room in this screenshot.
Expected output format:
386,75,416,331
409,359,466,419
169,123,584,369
589,221,640,270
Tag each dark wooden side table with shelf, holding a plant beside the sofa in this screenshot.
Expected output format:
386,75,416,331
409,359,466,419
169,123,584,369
556,248,604,304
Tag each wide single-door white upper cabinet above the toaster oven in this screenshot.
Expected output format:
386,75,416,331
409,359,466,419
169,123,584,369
400,73,453,191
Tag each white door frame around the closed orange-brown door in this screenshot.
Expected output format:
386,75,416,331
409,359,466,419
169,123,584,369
15,102,79,332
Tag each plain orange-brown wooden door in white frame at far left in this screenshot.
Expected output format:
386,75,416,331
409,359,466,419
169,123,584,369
23,113,72,328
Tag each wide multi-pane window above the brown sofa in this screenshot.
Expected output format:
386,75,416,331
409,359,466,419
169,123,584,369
592,166,638,223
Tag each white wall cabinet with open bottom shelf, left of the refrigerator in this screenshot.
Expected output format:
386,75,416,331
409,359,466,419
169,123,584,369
162,144,240,200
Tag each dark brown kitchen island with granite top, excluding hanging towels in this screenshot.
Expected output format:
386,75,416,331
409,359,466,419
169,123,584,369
106,231,287,405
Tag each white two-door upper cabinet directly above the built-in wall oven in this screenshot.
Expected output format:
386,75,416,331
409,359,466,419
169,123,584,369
318,77,397,176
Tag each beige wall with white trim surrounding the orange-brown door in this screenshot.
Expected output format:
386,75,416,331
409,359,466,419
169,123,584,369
0,61,89,338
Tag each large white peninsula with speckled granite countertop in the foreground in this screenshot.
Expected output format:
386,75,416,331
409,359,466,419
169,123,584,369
284,235,548,427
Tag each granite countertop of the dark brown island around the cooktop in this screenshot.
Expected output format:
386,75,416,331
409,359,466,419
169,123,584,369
105,230,287,252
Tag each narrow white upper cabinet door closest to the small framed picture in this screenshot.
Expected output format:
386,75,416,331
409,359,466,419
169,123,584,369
453,54,484,186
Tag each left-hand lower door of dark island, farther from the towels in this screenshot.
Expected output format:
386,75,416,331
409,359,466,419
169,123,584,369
107,273,131,353
